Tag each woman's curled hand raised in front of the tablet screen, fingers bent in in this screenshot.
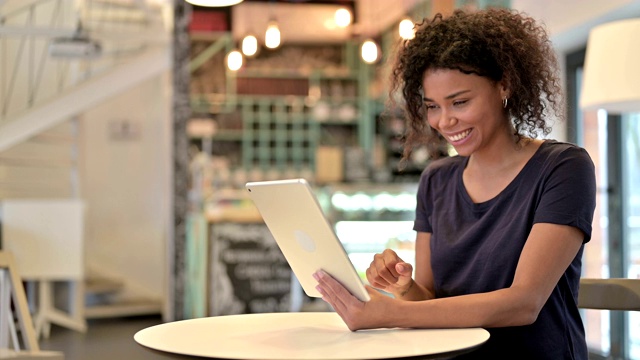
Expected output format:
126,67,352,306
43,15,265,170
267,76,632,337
367,249,413,298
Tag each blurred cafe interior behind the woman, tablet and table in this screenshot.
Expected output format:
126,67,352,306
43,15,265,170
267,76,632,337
0,0,640,359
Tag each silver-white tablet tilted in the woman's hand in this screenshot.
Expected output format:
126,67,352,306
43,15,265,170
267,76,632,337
246,179,369,301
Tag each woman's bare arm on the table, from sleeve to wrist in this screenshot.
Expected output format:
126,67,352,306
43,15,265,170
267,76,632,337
396,224,584,327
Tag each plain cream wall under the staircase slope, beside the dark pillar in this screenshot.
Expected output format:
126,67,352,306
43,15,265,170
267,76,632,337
80,73,173,298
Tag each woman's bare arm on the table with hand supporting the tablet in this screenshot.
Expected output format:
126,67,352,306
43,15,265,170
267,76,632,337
317,223,584,330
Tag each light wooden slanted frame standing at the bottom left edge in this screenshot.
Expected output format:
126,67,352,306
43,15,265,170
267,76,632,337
0,251,64,360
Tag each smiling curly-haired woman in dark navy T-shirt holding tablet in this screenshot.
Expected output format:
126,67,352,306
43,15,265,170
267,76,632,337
315,9,595,359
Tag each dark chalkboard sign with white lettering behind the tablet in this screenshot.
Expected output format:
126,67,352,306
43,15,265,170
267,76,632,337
209,223,293,316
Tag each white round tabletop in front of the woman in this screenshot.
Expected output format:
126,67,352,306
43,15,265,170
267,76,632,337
134,312,489,360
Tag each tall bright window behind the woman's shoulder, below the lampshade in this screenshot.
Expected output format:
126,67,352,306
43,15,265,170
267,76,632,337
566,50,640,359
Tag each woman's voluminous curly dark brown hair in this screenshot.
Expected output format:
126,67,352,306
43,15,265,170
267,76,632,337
389,8,564,160
